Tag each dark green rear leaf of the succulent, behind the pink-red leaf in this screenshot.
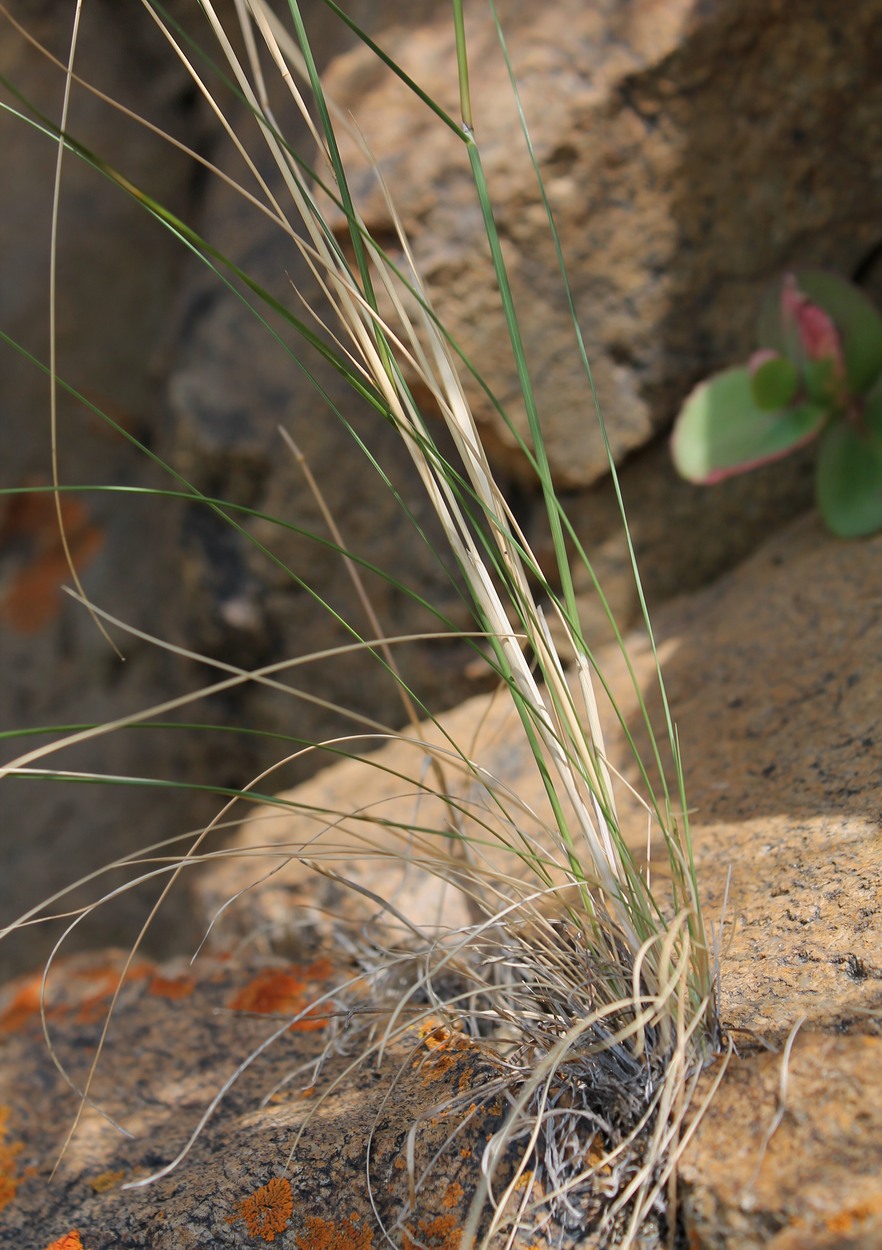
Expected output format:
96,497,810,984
757,269,882,395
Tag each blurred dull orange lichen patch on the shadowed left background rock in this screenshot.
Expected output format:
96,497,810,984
0,493,104,634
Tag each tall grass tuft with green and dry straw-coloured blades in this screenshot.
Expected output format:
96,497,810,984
2,0,718,1246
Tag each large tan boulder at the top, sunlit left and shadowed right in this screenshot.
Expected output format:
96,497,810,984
326,0,882,489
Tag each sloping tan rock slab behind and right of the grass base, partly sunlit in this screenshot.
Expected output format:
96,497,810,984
187,519,882,1250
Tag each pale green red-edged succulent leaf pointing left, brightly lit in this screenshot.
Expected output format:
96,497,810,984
671,368,828,484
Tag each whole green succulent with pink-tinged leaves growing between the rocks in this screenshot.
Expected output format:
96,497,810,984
672,269,882,538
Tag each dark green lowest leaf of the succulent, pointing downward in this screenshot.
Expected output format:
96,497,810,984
816,386,882,539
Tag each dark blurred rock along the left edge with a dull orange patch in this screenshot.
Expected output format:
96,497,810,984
0,0,224,975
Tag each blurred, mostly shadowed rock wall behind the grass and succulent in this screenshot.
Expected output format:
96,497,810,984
0,0,882,973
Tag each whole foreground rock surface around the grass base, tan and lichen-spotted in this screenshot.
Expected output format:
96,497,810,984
0,520,882,1250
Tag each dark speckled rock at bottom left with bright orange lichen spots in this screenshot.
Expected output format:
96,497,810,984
0,953,587,1250
